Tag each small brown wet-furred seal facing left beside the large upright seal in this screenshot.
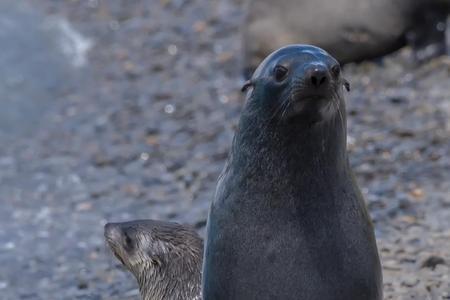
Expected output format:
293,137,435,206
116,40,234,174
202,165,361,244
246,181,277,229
105,220,203,300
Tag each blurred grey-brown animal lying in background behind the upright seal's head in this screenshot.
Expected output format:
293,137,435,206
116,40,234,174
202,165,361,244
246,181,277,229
243,0,450,77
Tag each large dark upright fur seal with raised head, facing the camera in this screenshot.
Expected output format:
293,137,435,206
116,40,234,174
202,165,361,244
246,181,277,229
202,45,382,300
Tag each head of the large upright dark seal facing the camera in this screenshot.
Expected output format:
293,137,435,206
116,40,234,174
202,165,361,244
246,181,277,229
242,45,350,122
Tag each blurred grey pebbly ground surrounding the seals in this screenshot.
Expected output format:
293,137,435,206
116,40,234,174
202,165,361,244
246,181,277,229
0,0,450,300
